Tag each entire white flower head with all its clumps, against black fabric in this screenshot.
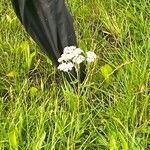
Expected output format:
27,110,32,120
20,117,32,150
58,46,96,72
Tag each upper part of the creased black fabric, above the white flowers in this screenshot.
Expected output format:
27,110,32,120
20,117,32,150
11,0,83,82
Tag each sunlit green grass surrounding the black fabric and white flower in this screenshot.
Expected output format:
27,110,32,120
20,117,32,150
0,0,150,150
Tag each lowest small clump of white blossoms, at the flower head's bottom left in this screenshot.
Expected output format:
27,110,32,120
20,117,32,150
58,62,74,72
